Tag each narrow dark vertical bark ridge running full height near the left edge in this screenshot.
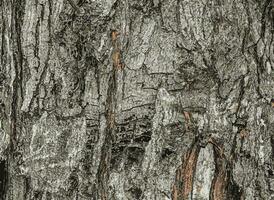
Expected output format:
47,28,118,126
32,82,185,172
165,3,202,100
5,0,25,199
